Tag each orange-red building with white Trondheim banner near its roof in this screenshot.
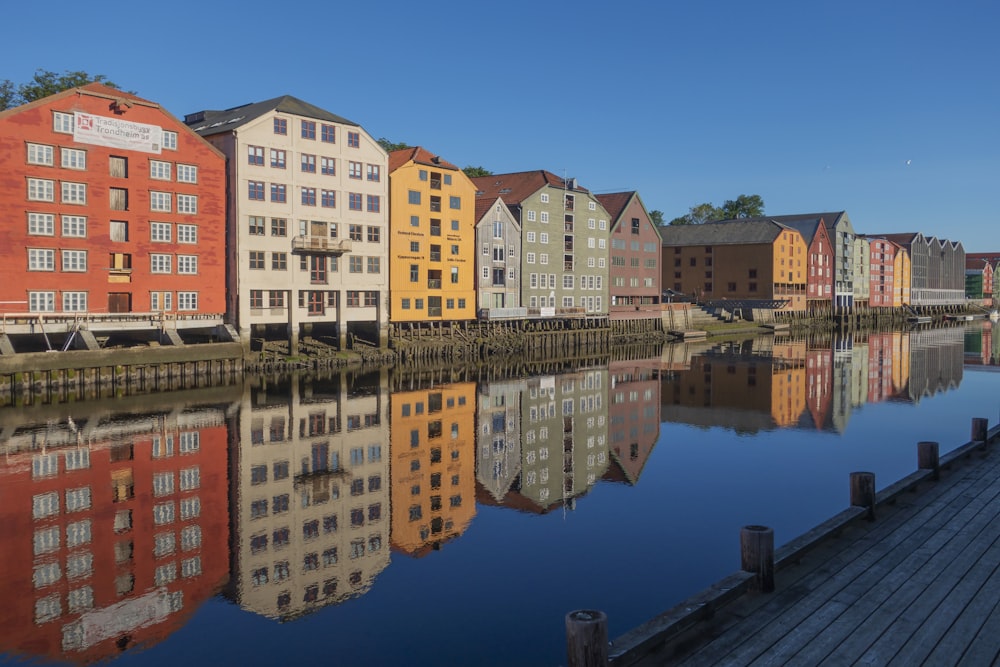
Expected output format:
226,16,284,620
0,83,226,350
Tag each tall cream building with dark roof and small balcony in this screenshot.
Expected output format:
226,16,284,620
184,95,389,354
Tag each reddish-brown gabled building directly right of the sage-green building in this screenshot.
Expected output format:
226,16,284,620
595,191,662,318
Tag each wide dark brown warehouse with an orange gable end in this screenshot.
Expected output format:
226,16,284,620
660,219,807,311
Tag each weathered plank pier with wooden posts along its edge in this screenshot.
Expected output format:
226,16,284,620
569,418,1000,667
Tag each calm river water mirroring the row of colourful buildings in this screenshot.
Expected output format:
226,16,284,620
0,325,1000,665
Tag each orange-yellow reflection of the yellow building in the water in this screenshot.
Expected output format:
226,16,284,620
390,382,476,557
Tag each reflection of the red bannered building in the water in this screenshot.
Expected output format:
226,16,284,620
0,396,229,663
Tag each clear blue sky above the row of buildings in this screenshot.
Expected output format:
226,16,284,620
0,0,1000,252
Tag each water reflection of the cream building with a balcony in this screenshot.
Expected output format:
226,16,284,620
226,372,390,621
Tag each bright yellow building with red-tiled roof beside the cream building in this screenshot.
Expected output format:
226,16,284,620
389,147,476,323
